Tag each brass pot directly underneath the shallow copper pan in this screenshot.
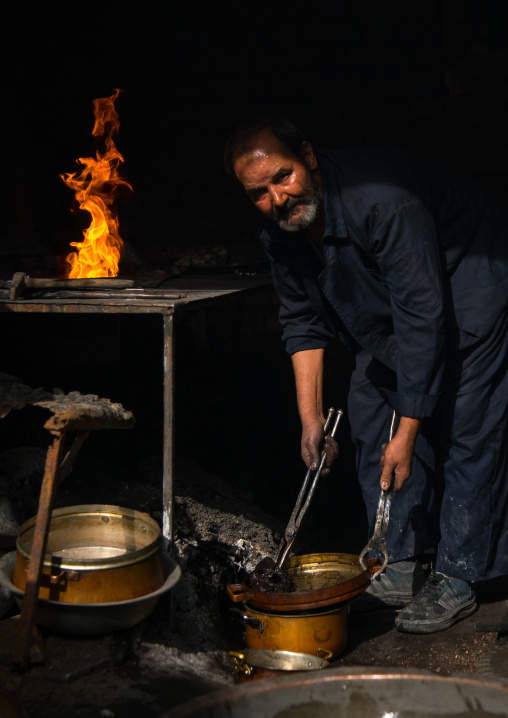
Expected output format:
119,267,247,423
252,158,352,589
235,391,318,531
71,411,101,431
231,604,348,658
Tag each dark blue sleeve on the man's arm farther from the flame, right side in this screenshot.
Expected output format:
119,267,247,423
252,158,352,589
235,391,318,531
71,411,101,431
371,200,445,418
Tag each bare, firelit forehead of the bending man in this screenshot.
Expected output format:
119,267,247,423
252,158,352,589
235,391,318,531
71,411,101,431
233,130,298,184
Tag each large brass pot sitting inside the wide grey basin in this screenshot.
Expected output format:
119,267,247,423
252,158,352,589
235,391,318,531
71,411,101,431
12,504,165,604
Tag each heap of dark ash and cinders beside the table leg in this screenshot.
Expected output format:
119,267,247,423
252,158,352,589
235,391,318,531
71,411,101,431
143,461,284,651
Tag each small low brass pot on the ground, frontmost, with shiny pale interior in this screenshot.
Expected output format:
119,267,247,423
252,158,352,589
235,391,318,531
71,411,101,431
229,648,331,683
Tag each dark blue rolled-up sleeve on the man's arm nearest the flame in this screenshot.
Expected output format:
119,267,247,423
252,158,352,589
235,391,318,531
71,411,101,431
261,234,334,354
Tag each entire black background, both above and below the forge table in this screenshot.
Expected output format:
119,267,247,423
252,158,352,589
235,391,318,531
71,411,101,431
0,0,508,552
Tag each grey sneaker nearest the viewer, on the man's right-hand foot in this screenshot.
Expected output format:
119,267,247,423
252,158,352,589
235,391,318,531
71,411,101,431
395,571,476,633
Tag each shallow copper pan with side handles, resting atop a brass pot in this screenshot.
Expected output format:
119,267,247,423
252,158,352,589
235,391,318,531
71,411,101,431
227,553,379,612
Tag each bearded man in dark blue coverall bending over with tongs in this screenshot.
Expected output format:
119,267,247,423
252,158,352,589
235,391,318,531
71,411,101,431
225,118,508,633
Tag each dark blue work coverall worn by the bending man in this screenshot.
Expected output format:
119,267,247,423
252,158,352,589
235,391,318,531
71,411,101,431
260,148,508,580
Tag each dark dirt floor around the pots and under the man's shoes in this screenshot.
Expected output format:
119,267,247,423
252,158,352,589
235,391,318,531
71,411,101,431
0,572,508,718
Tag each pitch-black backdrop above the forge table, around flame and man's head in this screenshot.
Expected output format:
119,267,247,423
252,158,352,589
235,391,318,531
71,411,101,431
0,0,508,269
